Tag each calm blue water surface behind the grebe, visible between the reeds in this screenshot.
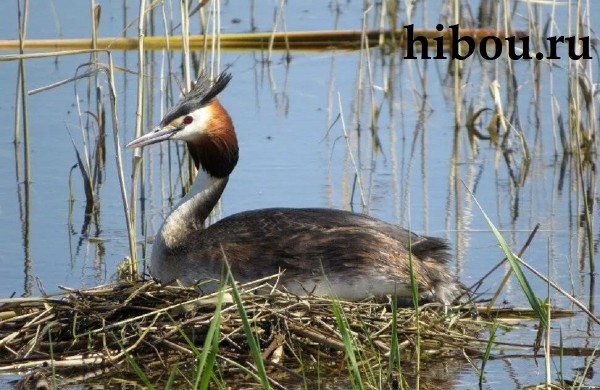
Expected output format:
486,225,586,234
0,1,600,388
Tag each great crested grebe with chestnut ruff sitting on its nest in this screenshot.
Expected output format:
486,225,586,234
127,73,465,304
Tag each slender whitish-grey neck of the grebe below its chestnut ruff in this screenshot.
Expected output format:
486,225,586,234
159,169,228,248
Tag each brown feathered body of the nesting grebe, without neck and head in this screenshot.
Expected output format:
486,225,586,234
152,208,461,303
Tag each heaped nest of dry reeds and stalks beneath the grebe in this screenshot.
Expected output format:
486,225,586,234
0,280,479,387
